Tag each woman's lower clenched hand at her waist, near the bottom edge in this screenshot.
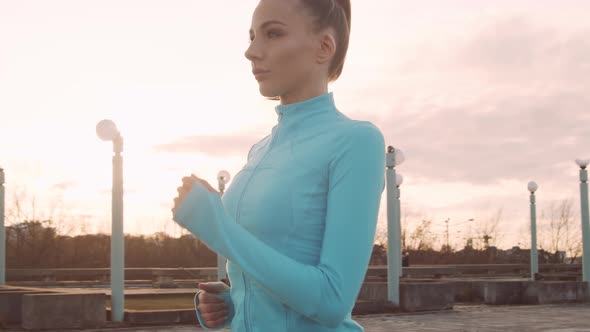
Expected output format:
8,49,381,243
197,281,229,327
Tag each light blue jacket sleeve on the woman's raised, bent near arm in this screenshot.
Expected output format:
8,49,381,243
174,121,385,327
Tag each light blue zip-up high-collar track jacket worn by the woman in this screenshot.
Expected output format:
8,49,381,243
174,92,385,332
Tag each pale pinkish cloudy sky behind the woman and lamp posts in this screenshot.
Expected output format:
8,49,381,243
0,0,590,247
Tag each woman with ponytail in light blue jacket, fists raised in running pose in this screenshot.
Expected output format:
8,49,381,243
173,0,385,332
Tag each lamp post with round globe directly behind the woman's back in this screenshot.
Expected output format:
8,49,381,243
385,146,404,306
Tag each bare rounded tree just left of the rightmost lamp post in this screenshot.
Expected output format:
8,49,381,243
539,199,582,263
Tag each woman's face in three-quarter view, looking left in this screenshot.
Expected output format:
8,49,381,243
245,0,327,97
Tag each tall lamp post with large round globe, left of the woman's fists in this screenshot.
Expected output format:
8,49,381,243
96,120,125,322
